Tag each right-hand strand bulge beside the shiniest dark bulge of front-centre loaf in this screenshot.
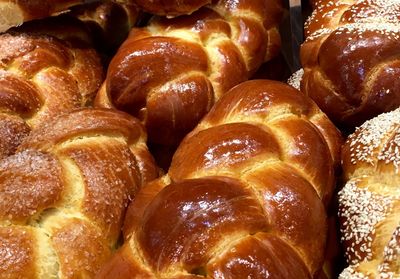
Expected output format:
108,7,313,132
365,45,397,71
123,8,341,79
241,164,326,270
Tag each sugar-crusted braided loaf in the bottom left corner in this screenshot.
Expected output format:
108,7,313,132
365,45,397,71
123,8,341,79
0,108,157,279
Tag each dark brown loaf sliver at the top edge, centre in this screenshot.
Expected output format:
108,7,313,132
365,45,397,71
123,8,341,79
132,0,212,17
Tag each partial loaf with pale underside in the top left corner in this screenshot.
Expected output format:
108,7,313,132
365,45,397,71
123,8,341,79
0,0,99,32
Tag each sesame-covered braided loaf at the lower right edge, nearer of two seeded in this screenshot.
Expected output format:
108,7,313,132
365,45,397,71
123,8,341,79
339,108,400,279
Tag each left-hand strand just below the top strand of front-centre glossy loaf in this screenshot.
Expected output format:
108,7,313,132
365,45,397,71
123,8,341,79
168,123,282,181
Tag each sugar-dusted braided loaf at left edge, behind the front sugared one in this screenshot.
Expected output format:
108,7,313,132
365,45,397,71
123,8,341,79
0,28,103,161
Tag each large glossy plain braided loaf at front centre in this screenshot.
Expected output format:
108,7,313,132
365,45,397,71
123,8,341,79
98,80,341,278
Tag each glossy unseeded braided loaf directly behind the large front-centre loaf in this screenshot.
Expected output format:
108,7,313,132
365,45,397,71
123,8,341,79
96,0,281,145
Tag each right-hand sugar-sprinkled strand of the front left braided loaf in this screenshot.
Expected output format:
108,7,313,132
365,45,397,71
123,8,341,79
60,140,141,243
